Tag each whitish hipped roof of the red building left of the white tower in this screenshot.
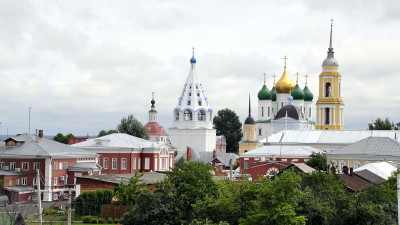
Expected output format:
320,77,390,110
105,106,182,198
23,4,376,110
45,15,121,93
72,133,165,149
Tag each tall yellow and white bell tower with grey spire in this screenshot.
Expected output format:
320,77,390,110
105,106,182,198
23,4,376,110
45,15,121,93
315,20,344,130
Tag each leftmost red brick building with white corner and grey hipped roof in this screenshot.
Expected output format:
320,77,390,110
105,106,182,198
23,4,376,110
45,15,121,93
0,132,101,202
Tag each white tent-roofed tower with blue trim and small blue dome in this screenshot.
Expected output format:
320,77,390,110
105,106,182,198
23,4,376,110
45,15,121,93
169,53,216,152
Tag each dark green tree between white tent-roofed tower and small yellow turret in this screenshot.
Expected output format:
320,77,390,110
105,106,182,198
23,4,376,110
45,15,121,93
213,109,243,153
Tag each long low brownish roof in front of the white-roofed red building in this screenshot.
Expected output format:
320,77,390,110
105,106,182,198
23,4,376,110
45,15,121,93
76,172,165,184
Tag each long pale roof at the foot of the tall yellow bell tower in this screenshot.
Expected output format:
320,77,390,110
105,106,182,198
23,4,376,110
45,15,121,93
267,130,400,144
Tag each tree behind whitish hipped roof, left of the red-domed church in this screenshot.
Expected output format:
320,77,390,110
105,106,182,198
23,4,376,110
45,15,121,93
117,114,150,140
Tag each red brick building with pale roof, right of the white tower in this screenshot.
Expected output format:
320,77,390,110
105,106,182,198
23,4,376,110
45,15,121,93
240,145,322,180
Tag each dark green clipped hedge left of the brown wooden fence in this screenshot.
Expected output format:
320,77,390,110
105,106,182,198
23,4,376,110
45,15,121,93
75,190,114,216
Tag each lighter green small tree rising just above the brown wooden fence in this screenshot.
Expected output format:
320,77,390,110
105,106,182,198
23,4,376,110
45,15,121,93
115,171,146,206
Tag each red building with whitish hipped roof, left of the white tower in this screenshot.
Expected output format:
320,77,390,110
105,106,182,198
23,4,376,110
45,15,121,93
72,133,177,174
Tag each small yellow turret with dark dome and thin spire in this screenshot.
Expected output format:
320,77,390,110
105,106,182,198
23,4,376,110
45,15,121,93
239,96,260,154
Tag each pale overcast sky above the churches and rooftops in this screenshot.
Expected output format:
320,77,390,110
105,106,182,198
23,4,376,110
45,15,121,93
0,0,400,135
